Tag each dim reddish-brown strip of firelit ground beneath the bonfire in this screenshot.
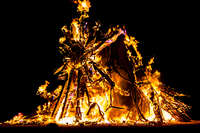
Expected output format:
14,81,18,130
0,120,200,131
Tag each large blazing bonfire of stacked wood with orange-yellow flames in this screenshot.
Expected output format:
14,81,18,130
5,0,191,125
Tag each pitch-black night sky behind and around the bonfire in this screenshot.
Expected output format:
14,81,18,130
0,0,200,121
